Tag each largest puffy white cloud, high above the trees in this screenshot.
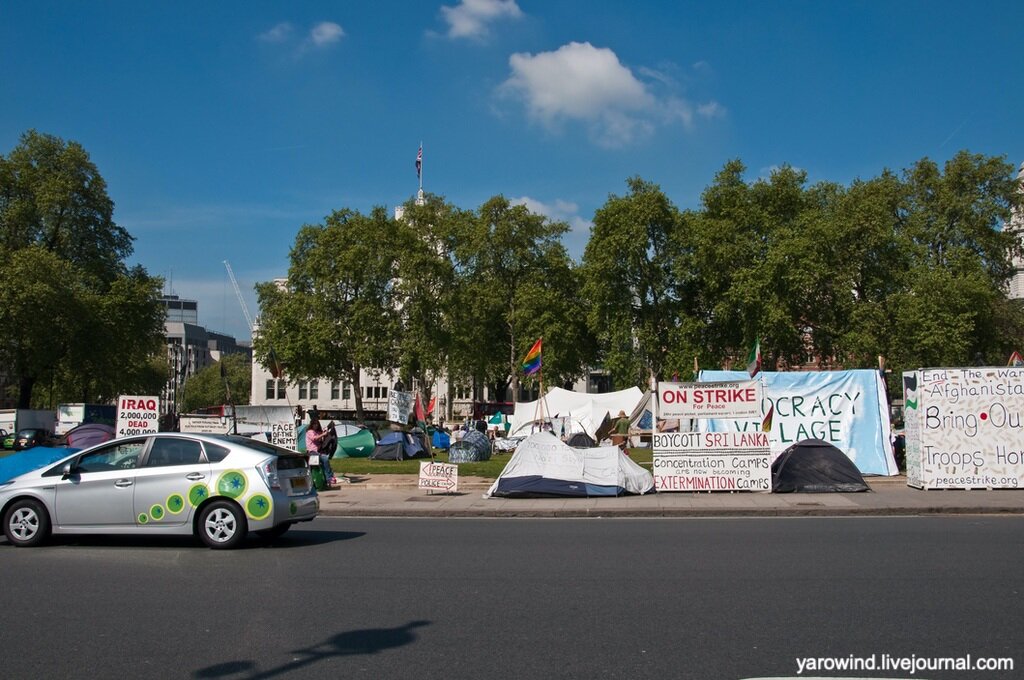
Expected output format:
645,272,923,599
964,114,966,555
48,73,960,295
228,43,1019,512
498,42,724,147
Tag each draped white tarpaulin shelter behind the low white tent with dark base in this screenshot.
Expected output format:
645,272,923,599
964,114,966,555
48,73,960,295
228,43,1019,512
509,387,643,438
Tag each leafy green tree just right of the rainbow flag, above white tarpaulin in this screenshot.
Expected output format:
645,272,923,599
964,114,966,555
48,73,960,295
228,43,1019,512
583,177,693,386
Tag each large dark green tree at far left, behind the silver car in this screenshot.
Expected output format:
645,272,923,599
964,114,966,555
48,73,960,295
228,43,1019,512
0,131,164,408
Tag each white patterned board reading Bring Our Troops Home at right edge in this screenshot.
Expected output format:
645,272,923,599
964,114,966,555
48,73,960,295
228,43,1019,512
903,368,1024,488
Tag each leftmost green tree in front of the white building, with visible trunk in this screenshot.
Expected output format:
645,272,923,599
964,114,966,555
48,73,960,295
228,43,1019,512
253,207,399,420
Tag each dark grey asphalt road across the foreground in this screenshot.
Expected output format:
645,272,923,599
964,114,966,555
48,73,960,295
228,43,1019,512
0,517,1024,680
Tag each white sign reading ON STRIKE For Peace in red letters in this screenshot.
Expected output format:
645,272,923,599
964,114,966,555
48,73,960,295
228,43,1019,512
657,380,762,419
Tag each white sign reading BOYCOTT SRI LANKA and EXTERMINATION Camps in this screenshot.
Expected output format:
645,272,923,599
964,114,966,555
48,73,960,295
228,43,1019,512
652,432,771,492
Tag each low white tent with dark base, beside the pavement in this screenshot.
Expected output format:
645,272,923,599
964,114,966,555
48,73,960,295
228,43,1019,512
484,432,654,498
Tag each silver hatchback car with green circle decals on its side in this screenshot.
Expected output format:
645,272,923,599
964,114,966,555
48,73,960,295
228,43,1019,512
0,432,319,548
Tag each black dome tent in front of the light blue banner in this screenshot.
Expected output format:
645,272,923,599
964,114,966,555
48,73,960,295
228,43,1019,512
771,439,870,494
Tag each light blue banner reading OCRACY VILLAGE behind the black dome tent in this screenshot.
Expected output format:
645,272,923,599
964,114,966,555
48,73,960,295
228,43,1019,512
697,369,899,475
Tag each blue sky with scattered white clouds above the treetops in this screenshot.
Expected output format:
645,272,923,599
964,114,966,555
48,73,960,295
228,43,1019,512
0,0,1024,337
